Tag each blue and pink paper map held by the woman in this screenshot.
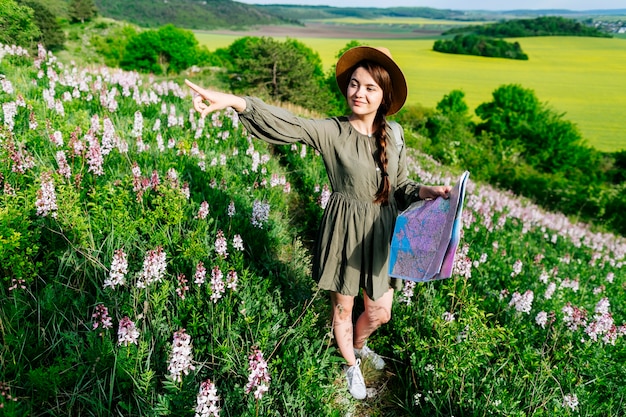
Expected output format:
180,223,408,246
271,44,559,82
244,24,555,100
389,171,469,281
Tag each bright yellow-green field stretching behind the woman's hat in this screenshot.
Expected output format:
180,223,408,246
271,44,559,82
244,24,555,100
196,25,626,151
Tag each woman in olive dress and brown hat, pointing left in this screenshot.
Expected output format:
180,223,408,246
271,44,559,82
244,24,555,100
185,46,450,399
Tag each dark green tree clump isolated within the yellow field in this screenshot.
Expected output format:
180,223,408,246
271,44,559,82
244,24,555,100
433,35,528,61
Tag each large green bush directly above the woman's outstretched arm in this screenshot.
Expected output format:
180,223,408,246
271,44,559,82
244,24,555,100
223,37,331,112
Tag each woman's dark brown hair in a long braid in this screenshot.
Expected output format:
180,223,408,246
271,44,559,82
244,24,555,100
352,61,393,205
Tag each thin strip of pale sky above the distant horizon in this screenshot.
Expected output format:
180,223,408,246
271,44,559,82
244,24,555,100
236,0,626,10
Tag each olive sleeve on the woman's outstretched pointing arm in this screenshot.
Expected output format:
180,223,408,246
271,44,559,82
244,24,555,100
239,97,332,151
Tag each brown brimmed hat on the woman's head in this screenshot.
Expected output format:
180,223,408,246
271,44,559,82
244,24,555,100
335,46,408,115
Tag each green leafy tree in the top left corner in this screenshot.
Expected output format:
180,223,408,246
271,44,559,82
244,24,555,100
0,0,41,49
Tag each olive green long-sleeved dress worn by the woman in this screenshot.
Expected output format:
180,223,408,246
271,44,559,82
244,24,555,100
239,97,419,300
